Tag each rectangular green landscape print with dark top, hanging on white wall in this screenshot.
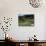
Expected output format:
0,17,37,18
18,14,34,26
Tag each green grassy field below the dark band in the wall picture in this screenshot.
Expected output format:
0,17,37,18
18,18,34,26
